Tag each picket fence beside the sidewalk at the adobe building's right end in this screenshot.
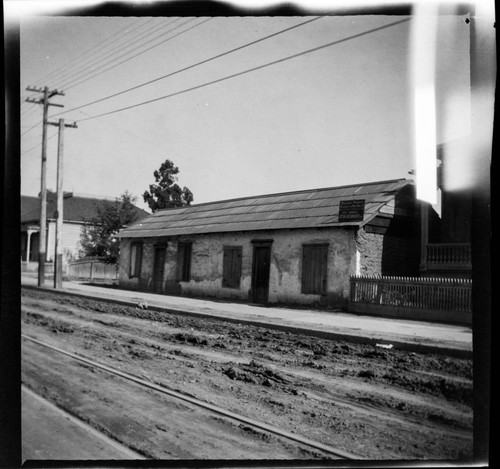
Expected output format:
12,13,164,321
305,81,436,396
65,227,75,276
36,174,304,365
349,276,472,324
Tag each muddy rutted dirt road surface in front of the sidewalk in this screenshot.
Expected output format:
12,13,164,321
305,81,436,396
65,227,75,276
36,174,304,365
21,289,473,460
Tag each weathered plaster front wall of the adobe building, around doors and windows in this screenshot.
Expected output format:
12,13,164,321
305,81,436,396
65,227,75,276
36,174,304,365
119,228,356,305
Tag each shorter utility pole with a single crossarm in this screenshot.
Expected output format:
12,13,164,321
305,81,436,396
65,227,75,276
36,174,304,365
47,119,77,288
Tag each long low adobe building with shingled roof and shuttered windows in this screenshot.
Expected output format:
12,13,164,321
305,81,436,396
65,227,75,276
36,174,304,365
119,179,430,307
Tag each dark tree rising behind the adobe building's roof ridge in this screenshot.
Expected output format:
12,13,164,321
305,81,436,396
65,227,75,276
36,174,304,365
143,160,193,213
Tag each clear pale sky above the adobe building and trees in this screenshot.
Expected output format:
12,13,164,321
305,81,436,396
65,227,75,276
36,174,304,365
20,4,470,212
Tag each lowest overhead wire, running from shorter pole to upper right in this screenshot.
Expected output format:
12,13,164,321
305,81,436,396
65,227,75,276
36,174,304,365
75,18,410,122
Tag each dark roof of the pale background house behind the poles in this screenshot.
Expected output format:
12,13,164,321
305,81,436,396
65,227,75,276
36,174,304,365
21,192,150,223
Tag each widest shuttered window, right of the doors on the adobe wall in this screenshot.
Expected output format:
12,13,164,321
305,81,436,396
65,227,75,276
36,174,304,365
302,244,328,295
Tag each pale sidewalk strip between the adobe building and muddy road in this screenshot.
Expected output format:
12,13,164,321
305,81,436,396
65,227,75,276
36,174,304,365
21,275,472,357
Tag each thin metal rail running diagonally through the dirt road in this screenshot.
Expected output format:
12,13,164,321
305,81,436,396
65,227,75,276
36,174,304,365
21,334,361,460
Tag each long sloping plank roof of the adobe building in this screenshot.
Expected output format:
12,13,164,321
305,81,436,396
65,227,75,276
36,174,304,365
119,179,413,238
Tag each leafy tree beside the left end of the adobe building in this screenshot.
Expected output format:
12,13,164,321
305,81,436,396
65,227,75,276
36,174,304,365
80,191,139,264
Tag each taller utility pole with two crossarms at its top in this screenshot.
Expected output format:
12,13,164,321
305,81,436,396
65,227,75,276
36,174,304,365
26,86,64,287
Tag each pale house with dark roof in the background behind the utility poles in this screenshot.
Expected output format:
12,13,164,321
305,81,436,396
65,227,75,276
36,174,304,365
21,191,149,271
